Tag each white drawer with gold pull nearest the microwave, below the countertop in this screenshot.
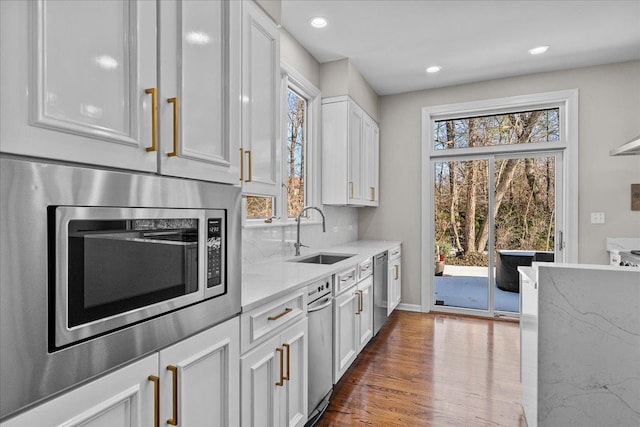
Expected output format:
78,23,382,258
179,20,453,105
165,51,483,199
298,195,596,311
240,291,307,353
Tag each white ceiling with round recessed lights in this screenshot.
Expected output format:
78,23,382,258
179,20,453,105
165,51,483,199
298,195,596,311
282,0,640,95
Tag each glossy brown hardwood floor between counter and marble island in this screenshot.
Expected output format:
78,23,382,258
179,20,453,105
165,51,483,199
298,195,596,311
317,310,526,427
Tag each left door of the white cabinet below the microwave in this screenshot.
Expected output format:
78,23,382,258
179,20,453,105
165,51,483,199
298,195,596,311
0,353,158,427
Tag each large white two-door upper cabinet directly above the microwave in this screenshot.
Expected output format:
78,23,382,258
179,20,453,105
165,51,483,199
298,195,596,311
0,0,241,184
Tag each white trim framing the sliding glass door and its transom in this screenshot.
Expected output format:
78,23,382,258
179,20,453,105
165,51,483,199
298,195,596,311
420,89,579,313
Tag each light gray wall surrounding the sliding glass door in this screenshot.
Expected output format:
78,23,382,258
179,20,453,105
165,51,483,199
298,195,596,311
358,61,640,305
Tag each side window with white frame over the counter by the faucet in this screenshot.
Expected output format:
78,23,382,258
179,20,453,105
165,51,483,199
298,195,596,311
244,65,320,226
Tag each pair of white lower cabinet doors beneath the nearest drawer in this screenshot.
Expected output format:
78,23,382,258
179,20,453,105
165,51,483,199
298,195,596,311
240,317,308,427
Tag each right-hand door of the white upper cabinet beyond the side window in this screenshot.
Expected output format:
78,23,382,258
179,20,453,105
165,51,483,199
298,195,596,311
362,116,380,206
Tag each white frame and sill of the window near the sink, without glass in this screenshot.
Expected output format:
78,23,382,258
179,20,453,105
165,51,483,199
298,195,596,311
242,63,322,227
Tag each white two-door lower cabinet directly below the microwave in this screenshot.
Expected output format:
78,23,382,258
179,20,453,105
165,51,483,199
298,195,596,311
1,317,240,427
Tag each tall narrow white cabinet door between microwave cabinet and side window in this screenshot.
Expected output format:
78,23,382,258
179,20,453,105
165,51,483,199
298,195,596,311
240,1,282,196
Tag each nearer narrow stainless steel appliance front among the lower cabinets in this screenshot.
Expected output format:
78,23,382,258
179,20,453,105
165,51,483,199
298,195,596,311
305,276,333,426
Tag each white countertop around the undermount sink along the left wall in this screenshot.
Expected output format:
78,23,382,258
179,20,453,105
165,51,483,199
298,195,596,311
242,240,401,312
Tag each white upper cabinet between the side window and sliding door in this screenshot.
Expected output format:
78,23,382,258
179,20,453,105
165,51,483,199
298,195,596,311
322,96,379,206
